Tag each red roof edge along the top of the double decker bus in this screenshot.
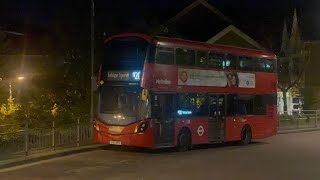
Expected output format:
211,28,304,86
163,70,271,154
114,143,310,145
105,33,276,60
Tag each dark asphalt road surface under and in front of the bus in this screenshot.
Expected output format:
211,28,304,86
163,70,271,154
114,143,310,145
0,131,320,180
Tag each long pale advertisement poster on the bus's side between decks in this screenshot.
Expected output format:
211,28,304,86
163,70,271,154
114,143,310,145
178,68,256,88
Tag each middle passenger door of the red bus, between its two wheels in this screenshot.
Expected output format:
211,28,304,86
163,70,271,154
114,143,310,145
208,95,225,142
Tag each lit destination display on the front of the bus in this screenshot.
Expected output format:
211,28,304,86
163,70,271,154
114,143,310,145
107,71,141,81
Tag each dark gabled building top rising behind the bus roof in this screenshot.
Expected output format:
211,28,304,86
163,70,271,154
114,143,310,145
160,0,265,50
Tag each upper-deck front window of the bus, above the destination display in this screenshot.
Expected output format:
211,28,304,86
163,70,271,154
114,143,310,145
104,37,148,70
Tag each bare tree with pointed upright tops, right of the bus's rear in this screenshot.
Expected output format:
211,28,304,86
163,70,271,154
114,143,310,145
278,10,310,113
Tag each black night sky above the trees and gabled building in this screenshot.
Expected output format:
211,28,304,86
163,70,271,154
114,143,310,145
0,0,320,52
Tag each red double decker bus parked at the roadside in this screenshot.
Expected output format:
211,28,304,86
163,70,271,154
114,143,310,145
95,34,277,150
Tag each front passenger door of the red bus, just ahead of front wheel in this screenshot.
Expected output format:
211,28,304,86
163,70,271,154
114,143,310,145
152,93,176,147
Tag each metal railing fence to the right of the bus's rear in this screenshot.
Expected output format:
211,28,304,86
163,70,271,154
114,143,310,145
278,110,320,130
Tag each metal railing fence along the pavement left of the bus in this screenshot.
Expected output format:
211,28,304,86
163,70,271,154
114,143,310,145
0,120,93,160
